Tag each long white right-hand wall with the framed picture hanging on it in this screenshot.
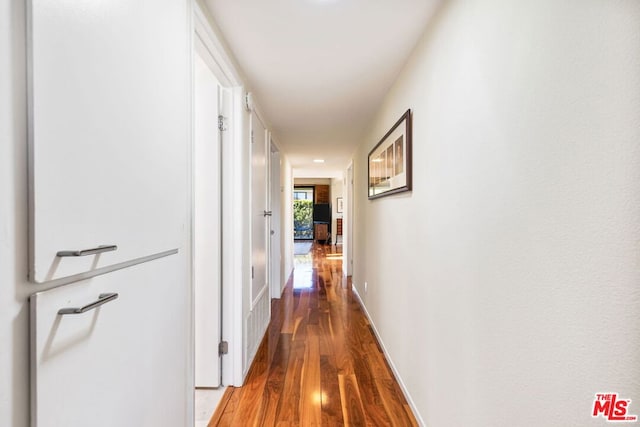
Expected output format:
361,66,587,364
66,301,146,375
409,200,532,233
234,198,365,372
354,0,640,427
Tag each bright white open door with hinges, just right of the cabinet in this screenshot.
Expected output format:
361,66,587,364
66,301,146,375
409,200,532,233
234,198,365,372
193,54,222,387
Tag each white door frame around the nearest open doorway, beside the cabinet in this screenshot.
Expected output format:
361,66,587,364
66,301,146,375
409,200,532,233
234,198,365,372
190,0,246,390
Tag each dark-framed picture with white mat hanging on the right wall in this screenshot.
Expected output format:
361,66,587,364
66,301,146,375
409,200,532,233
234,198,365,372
367,109,412,199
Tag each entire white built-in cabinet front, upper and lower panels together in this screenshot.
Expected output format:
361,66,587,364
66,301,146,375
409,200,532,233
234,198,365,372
27,0,192,427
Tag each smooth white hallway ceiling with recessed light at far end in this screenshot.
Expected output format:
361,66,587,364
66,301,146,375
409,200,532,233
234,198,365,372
206,0,439,177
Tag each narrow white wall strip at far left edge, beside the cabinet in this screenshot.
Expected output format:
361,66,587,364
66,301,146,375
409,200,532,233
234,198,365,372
0,1,29,427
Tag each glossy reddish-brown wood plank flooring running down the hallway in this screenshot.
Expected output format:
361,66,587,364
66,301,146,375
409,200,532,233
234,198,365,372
209,244,417,427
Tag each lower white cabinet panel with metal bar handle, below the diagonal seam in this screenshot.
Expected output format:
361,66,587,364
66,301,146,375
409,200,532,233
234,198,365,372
30,256,188,427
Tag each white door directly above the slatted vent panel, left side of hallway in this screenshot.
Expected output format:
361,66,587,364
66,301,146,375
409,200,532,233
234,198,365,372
251,112,270,308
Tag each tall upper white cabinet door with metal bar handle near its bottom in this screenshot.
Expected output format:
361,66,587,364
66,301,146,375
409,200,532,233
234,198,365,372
28,0,190,282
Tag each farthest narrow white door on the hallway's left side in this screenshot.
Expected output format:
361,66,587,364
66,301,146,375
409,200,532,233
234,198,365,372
269,141,282,298
